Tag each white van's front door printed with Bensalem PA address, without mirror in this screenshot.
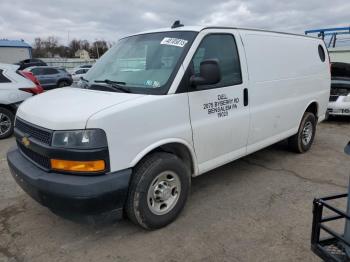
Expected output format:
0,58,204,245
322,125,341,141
188,29,249,173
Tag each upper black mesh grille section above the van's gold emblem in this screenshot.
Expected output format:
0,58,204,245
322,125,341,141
15,118,52,145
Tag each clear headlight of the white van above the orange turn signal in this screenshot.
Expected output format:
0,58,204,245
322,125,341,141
52,129,107,149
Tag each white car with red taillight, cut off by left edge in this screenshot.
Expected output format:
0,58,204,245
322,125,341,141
0,64,42,139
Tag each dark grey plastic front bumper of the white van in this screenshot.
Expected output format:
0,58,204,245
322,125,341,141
7,148,132,218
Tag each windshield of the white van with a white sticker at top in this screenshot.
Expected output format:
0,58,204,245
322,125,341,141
85,31,197,94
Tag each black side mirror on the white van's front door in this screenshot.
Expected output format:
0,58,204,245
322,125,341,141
190,59,221,86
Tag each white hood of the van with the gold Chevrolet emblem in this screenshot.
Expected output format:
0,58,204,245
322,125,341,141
17,87,144,130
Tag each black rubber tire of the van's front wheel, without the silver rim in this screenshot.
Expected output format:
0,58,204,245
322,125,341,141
125,152,191,229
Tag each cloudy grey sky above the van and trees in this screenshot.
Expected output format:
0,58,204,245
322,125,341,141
0,0,350,44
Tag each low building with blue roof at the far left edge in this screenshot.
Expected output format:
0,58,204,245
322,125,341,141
0,39,32,64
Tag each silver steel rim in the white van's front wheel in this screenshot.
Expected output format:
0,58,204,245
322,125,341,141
147,171,181,215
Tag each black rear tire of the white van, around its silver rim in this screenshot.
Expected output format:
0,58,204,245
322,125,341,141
288,112,316,153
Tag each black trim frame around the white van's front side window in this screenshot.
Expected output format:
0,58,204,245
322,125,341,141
175,32,244,94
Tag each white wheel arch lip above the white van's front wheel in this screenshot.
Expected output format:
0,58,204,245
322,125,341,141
130,138,198,176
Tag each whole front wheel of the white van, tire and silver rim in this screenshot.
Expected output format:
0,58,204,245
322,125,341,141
126,152,191,229
